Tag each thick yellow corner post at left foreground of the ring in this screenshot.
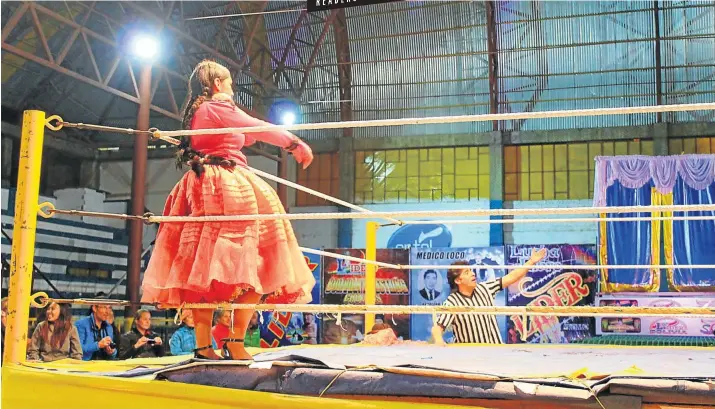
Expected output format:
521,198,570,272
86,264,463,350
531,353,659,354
4,111,45,363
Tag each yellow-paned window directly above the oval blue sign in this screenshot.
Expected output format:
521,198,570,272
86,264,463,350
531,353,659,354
355,146,489,203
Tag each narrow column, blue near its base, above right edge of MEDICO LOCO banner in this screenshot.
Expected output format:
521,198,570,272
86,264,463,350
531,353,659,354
489,131,504,246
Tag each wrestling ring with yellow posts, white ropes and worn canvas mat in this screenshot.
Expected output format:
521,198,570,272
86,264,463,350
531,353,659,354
2,103,715,409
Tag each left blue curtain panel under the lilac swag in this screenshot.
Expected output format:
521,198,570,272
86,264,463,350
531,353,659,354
599,181,653,291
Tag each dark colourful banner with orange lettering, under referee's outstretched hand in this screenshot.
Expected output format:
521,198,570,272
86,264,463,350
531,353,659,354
506,244,598,344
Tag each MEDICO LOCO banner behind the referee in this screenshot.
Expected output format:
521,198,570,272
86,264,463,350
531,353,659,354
410,247,506,342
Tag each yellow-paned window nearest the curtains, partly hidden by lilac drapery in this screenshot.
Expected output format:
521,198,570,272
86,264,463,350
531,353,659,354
504,140,653,200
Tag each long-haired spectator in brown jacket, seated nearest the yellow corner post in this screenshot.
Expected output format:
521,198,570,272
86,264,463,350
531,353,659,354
27,302,82,362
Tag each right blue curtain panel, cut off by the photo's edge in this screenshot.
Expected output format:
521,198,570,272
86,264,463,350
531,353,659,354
670,177,715,290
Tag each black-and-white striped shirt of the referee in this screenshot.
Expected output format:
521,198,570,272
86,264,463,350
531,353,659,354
437,278,504,344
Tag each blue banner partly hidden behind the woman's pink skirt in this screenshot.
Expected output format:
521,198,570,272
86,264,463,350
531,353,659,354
259,253,321,348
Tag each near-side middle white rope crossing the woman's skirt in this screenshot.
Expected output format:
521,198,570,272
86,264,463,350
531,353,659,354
148,205,715,223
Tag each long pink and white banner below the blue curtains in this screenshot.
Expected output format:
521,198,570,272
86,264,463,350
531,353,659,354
596,293,715,337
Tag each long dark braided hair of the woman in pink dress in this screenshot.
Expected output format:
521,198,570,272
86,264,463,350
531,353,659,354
176,60,232,176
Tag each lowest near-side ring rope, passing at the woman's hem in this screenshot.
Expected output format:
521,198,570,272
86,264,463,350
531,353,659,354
32,293,715,318
